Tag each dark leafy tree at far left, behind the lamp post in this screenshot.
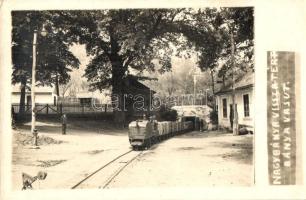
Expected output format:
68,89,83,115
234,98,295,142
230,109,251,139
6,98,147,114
12,11,80,113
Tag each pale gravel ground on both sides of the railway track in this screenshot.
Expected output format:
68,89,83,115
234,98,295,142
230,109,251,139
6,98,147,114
12,121,253,190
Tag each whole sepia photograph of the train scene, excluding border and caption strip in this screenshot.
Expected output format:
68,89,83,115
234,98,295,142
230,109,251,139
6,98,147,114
11,7,255,190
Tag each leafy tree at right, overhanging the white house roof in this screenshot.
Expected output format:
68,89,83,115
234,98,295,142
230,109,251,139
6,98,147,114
196,7,254,93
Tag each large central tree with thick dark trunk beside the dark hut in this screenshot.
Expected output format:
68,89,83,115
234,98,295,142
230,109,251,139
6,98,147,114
75,9,215,122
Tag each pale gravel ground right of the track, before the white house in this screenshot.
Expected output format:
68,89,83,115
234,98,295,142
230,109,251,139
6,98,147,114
109,132,254,188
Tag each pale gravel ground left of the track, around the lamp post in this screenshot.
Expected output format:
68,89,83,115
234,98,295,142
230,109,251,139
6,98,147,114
12,121,130,190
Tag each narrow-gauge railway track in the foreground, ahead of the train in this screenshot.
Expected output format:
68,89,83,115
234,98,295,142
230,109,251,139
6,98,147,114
71,150,143,189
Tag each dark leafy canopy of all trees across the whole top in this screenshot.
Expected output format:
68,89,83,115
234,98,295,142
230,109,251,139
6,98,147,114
12,8,253,123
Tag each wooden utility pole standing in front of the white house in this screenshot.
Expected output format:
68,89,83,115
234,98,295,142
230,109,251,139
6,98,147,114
230,30,238,135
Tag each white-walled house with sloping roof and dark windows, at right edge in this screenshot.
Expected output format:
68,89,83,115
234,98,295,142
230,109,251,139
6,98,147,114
215,72,254,131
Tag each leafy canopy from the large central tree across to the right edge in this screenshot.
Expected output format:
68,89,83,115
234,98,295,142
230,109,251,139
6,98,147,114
74,8,253,122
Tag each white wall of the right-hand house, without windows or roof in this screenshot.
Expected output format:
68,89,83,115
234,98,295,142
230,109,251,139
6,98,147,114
217,89,254,128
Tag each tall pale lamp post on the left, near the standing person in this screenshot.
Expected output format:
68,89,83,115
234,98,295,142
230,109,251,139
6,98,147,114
31,30,37,146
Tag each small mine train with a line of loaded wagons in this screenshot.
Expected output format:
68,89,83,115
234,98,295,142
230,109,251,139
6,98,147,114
128,119,194,150
